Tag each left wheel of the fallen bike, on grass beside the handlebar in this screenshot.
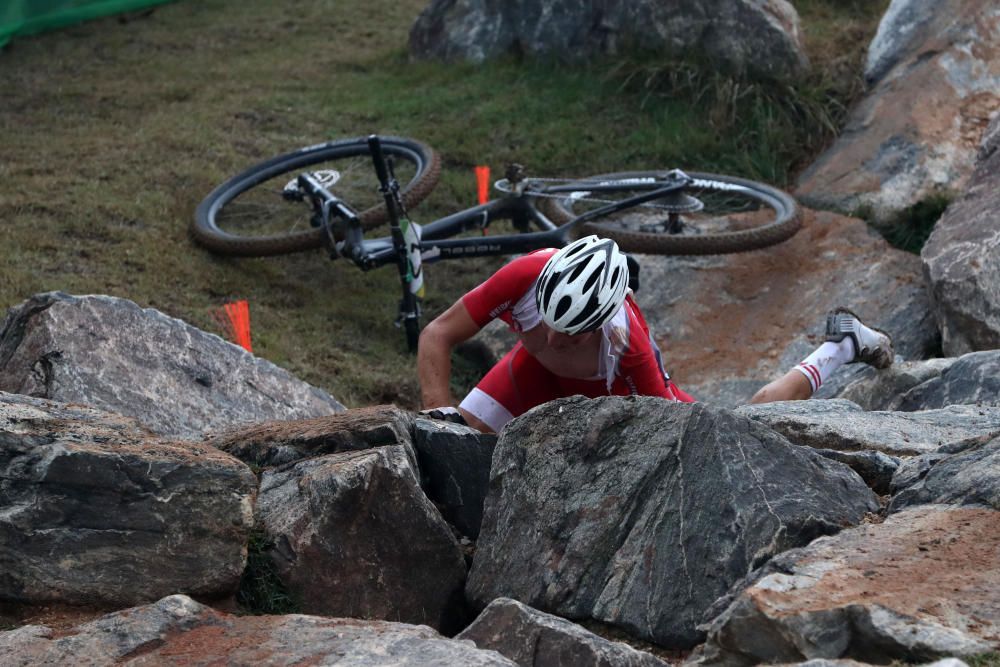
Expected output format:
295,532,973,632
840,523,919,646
191,137,441,257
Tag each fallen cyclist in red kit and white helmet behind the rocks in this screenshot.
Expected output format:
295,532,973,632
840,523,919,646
417,236,893,432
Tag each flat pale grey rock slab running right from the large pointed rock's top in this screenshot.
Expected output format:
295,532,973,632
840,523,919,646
736,399,1000,456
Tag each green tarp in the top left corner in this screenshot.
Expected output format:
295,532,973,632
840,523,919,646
0,0,177,46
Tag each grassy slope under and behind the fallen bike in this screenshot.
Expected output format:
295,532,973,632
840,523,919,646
0,0,886,407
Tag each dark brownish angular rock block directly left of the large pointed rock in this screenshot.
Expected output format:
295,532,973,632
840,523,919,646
257,446,466,632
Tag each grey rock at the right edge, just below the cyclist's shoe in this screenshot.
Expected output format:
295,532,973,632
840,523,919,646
837,350,1000,412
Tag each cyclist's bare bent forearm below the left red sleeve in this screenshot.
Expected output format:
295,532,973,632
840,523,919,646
417,299,479,408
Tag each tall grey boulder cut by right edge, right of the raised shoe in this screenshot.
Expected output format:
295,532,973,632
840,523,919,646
920,113,1000,356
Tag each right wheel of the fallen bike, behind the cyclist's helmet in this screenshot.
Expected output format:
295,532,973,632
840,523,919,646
539,171,801,255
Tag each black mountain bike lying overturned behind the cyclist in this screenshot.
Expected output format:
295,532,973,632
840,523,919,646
191,135,800,351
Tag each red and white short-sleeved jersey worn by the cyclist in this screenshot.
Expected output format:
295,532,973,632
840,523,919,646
462,248,694,402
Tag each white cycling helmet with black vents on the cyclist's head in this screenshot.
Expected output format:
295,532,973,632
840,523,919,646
535,236,628,334
